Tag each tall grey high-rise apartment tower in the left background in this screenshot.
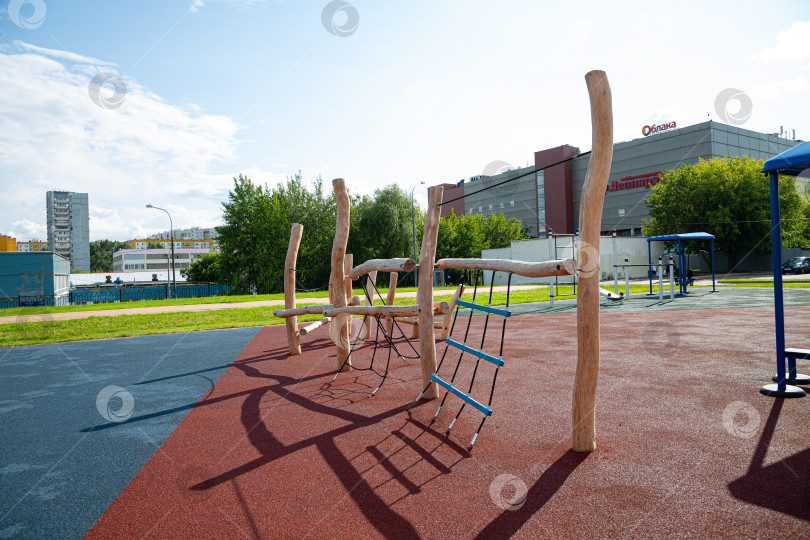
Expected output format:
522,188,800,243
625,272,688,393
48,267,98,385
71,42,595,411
45,191,90,272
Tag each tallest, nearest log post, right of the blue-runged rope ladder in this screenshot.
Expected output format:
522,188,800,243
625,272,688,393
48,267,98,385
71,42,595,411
571,71,613,452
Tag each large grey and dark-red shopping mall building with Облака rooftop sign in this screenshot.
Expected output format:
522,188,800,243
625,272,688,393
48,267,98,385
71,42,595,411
441,121,806,237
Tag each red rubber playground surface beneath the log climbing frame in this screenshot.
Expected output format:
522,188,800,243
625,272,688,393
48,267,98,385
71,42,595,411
88,307,810,538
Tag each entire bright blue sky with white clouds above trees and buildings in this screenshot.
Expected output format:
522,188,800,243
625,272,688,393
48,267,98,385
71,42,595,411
0,0,810,240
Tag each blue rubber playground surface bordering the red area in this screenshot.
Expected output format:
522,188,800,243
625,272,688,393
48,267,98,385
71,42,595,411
0,328,259,538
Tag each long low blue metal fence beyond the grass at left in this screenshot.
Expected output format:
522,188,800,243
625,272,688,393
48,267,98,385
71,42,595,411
0,283,230,309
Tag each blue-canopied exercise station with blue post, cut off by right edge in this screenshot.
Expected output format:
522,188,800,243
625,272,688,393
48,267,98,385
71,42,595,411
759,142,810,397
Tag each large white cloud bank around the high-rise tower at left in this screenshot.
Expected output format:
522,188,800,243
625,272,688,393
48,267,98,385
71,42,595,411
0,43,249,240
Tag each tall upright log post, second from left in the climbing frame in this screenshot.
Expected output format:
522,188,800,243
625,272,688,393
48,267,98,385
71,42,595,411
327,178,352,371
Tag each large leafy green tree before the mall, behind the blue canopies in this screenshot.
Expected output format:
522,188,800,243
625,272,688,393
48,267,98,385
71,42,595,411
642,157,805,267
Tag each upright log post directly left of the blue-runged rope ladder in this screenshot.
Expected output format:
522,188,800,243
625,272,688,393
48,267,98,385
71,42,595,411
416,186,444,399
